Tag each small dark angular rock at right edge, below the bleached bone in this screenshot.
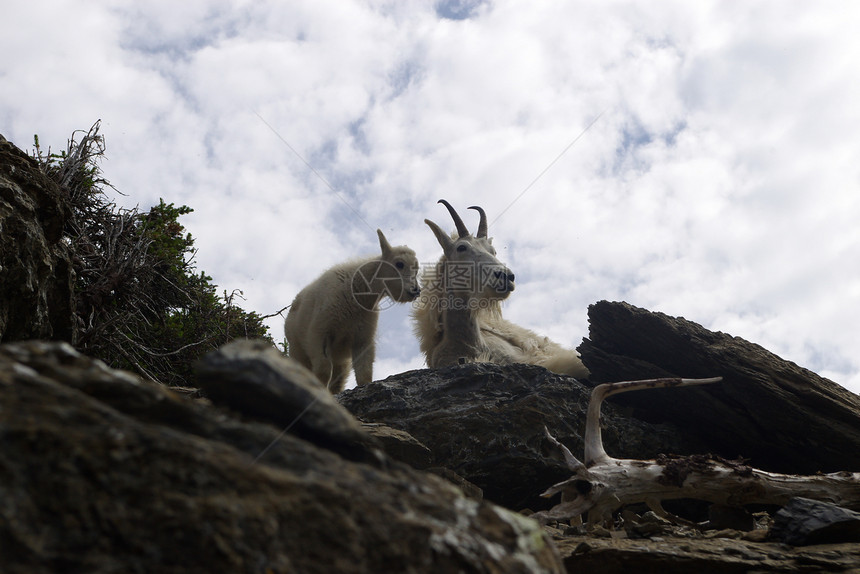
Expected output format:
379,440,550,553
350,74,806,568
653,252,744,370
770,497,860,546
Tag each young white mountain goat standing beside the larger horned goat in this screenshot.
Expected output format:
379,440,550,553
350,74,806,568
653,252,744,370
284,229,420,394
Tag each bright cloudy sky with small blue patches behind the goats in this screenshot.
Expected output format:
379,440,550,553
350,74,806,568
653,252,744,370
0,0,860,392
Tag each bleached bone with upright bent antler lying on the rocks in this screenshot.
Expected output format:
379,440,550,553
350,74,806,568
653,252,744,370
534,377,860,525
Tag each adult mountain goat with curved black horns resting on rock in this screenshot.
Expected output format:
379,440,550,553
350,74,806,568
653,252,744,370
412,199,589,378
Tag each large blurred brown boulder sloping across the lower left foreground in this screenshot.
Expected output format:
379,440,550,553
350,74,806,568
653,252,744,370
0,342,563,574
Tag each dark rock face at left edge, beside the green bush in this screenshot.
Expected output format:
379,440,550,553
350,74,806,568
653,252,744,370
0,135,75,342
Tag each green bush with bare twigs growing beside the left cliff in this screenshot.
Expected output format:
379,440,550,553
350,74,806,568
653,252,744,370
34,122,271,386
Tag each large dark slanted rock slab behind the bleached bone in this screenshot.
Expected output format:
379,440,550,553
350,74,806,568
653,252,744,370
574,301,860,474
